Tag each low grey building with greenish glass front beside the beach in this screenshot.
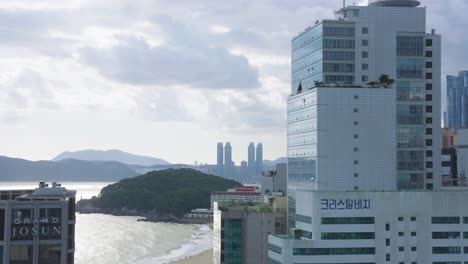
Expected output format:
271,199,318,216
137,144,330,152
213,196,287,264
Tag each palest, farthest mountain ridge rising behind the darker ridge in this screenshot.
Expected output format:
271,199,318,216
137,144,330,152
52,149,170,166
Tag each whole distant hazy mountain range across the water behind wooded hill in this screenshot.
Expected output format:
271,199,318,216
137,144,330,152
0,150,286,182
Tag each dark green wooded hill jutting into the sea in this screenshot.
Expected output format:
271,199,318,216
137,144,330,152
77,169,241,221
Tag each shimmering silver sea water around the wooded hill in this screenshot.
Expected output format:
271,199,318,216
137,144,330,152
0,182,213,264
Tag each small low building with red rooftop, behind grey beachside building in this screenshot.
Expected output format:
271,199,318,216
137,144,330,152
211,186,262,210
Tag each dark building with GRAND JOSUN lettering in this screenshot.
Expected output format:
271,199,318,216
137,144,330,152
0,182,76,264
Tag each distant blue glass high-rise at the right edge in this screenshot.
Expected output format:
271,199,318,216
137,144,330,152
446,71,468,130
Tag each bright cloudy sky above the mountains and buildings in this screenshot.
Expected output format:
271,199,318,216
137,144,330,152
0,0,468,164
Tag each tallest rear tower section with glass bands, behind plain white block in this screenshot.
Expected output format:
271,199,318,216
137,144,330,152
291,0,441,192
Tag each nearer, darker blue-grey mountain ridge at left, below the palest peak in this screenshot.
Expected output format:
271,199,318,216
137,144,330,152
0,156,137,182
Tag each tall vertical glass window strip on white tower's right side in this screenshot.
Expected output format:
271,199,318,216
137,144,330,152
396,33,426,189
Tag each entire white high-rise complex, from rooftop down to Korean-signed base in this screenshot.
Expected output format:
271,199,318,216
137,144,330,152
268,0,468,264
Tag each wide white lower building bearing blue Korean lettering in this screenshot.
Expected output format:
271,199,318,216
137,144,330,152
269,190,468,264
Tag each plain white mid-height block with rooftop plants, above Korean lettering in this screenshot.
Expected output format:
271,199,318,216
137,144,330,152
288,87,396,191
